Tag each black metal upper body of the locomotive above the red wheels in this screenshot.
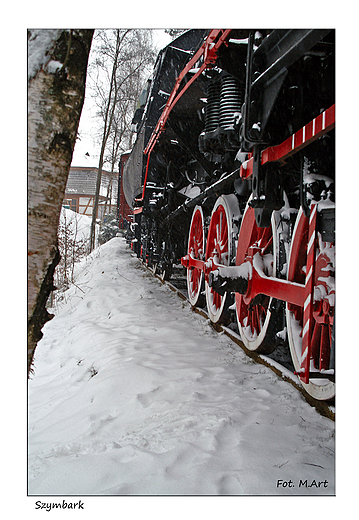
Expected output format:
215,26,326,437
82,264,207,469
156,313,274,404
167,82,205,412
123,29,335,246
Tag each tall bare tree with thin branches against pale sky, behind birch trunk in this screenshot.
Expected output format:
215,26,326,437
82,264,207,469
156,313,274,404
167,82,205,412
89,29,155,251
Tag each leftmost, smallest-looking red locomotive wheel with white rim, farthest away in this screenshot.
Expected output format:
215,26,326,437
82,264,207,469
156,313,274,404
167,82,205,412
187,206,205,305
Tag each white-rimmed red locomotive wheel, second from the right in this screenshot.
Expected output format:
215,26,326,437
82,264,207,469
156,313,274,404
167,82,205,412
236,197,277,351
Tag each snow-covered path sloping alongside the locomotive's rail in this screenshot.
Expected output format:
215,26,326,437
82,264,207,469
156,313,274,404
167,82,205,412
29,238,335,495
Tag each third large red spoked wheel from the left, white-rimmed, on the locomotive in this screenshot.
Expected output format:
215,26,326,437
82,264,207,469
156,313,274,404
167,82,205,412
236,201,277,353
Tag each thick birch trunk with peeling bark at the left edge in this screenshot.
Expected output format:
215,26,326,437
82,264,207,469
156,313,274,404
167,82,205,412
28,29,93,373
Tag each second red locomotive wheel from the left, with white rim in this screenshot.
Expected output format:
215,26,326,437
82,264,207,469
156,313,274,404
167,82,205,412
205,196,232,323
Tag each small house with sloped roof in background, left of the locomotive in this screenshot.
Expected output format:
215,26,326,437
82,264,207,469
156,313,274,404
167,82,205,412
63,166,118,220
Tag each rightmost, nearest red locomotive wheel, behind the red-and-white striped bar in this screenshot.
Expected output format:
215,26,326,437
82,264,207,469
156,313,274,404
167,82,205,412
286,209,335,400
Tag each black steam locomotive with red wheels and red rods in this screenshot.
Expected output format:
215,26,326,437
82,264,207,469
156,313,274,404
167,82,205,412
121,29,335,400
